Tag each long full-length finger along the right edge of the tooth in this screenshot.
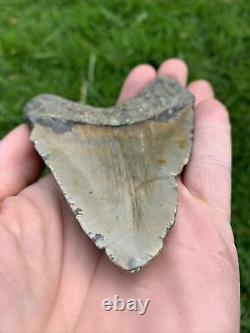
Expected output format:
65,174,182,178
183,99,231,212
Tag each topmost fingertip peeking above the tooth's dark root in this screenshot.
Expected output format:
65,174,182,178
157,59,188,86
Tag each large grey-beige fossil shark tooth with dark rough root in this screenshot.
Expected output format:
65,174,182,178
25,77,194,272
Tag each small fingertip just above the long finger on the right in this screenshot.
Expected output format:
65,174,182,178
187,80,214,105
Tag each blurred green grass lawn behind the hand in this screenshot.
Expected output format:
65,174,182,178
0,0,250,332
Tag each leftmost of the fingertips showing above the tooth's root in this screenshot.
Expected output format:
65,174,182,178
118,65,156,103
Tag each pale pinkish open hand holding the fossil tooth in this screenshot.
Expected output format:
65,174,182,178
0,59,240,333
